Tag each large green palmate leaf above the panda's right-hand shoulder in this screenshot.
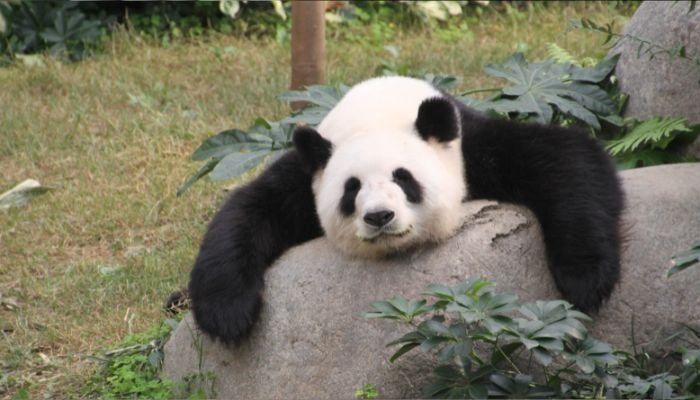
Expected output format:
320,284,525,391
484,53,617,129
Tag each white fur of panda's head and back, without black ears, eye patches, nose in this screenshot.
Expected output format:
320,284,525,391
313,77,465,257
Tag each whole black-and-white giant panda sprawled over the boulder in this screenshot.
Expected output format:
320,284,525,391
188,77,624,343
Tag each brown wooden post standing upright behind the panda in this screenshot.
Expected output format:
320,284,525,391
291,0,326,109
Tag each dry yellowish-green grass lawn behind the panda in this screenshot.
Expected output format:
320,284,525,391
0,3,630,398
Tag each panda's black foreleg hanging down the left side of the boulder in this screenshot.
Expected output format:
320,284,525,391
189,150,323,343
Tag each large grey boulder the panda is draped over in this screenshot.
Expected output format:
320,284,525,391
163,164,700,399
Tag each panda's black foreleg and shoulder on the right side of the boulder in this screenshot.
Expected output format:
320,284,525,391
458,104,624,311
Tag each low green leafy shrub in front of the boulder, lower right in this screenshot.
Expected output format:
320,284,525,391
365,278,700,399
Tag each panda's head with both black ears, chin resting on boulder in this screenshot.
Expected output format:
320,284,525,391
294,97,465,258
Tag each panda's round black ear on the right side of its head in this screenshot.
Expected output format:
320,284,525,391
416,97,460,143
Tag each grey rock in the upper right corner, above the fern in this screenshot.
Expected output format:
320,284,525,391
610,1,700,123
